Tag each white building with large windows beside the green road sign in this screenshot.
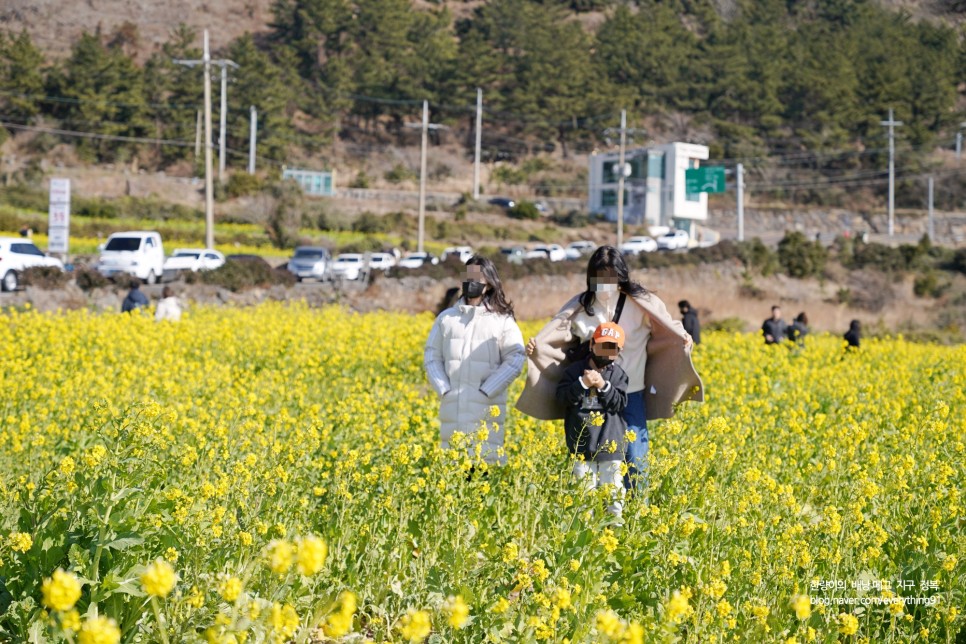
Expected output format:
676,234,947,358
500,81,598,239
587,143,708,237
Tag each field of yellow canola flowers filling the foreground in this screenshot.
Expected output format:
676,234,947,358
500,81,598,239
0,303,966,643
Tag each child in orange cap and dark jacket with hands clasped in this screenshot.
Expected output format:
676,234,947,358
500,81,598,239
557,322,627,520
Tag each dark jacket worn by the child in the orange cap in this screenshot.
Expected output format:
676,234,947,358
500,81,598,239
557,360,627,462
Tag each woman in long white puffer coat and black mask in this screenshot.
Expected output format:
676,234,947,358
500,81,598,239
423,256,526,465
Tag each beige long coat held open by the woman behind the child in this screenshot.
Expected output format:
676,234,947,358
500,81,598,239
516,293,704,420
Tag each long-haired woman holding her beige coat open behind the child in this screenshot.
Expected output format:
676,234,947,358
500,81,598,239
516,246,704,489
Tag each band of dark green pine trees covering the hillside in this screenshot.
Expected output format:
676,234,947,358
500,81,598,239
0,0,966,207
